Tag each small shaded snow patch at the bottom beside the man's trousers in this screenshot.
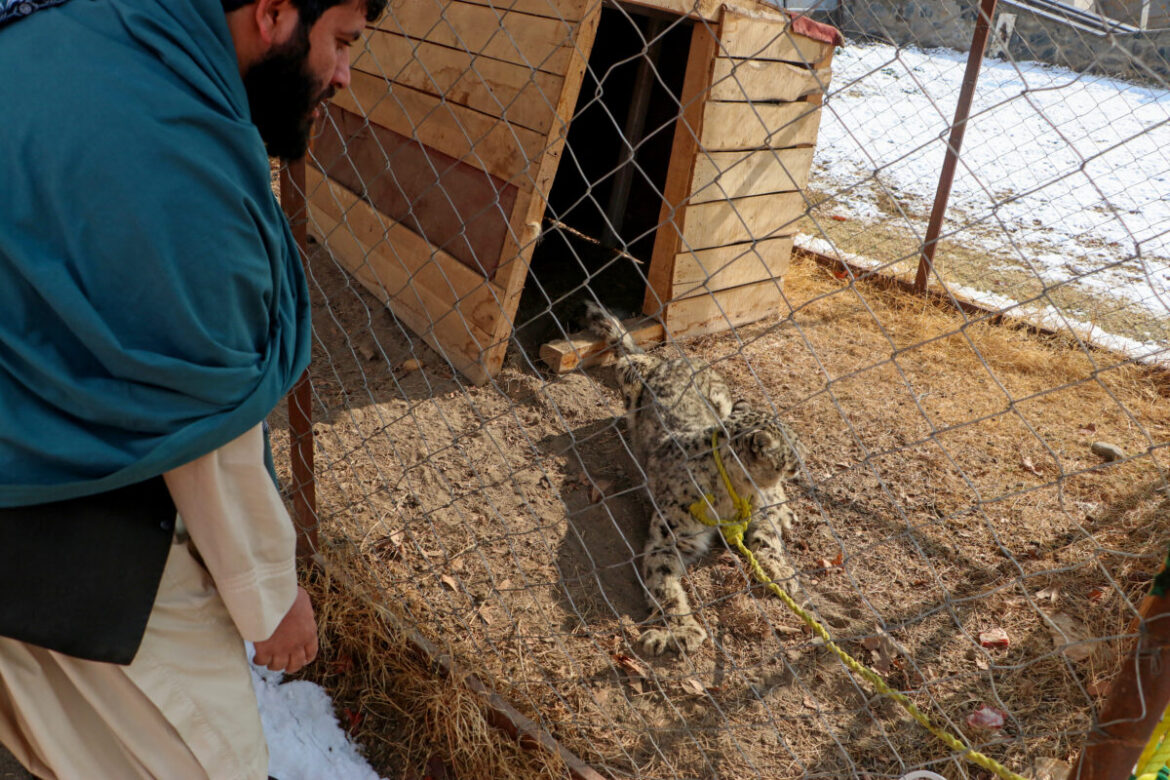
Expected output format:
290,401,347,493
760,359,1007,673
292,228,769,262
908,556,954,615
248,646,379,780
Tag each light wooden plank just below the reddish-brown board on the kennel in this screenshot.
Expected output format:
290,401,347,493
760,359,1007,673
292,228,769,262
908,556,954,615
305,167,502,359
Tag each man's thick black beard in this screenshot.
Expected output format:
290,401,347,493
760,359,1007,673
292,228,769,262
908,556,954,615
243,26,333,160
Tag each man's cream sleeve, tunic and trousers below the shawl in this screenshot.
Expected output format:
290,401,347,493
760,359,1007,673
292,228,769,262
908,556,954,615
0,426,296,780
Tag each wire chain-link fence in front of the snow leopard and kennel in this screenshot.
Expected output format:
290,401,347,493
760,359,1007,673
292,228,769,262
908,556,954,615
277,0,1170,779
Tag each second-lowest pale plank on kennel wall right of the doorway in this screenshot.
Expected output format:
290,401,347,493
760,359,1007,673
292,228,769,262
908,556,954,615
674,236,792,298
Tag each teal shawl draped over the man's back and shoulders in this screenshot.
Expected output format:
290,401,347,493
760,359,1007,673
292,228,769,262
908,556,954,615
0,0,310,506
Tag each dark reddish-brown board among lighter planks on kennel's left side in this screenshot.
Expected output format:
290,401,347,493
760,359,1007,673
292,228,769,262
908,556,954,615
312,105,516,277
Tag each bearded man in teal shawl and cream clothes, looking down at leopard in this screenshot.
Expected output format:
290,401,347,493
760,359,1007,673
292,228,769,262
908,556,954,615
0,0,385,780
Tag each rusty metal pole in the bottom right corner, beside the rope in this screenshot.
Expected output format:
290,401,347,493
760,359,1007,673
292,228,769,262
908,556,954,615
1068,594,1170,780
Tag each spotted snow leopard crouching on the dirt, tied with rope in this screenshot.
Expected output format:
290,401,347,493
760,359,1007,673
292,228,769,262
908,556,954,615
586,304,799,655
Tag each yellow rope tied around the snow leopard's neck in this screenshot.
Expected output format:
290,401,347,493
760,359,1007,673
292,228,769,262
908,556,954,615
690,430,1026,780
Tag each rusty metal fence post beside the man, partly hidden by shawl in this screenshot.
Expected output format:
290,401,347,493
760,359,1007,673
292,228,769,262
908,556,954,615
281,159,318,558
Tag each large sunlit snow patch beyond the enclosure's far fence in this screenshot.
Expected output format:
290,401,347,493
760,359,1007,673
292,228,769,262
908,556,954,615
813,42,1170,336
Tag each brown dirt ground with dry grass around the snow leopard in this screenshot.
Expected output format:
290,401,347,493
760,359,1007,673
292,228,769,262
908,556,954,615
274,239,1170,780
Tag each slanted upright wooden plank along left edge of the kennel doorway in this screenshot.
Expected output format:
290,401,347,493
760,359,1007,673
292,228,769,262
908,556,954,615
483,4,601,375
